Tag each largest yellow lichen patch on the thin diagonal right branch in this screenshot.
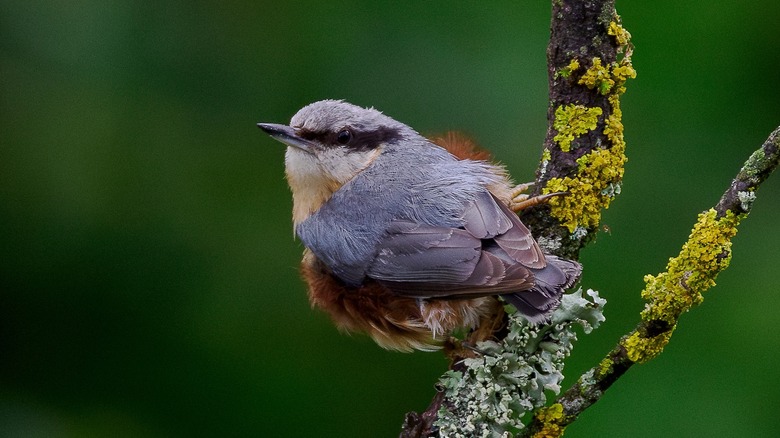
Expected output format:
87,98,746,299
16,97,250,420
642,209,740,324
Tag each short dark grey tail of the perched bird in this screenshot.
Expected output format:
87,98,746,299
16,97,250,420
501,255,582,324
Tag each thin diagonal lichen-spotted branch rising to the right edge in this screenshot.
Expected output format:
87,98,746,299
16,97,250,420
522,127,780,437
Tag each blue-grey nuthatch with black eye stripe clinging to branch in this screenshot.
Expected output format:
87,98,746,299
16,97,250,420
258,100,582,351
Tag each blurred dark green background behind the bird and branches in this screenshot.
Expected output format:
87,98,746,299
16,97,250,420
0,0,780,437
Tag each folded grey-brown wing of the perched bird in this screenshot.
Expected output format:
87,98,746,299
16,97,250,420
366,191,546,298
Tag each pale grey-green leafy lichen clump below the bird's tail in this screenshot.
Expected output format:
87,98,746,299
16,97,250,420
436,288,606,437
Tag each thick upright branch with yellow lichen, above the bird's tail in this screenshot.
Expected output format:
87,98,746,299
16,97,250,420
522,0,636,259
